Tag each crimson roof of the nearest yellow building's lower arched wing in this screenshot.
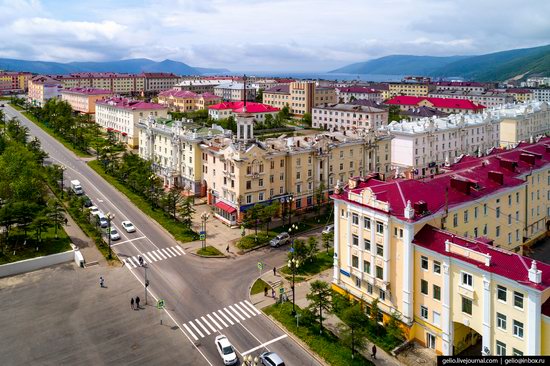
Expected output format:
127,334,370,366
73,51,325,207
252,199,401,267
413,225,550,291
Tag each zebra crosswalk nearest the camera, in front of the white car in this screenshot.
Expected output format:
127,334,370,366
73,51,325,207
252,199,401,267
182,300,261,341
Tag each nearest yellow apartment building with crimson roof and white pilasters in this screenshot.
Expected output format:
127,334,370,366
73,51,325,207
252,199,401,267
332,138,550,355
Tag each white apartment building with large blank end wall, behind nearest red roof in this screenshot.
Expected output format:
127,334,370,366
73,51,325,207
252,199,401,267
381,113,500,177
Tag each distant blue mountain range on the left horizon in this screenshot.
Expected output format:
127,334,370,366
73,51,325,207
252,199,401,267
0,58,229,75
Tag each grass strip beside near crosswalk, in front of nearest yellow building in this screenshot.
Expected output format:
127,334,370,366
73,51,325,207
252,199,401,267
262,302,373,366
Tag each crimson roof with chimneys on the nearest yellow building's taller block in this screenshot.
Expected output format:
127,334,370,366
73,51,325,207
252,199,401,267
332,138,550,221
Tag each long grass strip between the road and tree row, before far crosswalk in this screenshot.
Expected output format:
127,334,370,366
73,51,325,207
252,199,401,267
88,160,199,243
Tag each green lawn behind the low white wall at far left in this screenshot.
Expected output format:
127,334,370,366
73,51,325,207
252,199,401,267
0,227,71,264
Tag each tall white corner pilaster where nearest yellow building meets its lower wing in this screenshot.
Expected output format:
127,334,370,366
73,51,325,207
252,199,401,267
401,223,414,323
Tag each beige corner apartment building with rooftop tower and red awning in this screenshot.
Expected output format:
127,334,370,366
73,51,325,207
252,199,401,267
201,115,391,225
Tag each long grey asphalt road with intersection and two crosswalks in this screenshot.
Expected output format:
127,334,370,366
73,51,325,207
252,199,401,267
4,105,319,365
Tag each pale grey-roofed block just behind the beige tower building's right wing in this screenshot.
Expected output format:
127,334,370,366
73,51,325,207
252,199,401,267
311,103,388,131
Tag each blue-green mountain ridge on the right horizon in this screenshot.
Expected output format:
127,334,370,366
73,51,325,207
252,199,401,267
331,45,550,81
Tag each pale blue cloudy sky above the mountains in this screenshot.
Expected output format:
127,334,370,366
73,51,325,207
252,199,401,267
0,0,550,72
